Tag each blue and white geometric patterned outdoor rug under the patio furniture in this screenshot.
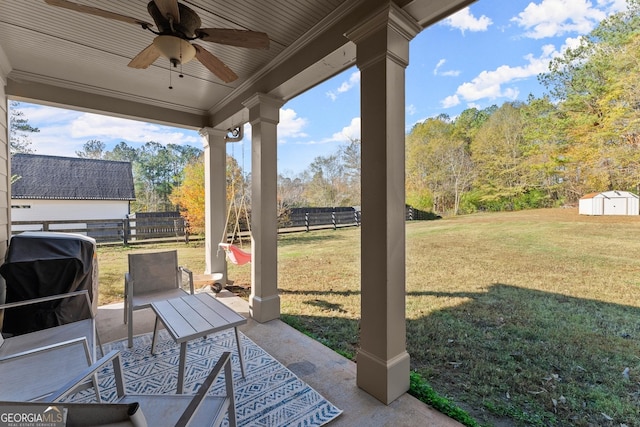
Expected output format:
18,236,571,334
73,329,342,427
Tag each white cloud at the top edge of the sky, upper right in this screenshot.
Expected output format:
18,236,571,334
511,0,618,39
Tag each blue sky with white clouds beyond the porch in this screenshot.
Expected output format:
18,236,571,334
12,0,626,176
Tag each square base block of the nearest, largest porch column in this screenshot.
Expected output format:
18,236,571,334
356,349,410,405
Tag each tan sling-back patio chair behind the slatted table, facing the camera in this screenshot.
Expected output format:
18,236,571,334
124,250,194,348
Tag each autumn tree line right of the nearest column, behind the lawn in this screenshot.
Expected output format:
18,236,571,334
406,0,640,214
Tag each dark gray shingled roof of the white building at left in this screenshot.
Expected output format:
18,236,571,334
11,154,135,200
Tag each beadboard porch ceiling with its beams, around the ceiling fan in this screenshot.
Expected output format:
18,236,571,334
0,0,472,128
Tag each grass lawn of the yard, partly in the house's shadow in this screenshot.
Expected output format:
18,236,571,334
98,209,640,426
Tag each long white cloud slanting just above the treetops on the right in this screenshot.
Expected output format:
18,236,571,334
440,44,573,108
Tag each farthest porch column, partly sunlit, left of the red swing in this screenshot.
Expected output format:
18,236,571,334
199,128,227,286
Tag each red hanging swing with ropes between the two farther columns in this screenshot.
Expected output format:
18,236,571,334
218,142,251,265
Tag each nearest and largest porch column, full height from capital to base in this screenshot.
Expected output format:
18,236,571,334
347,3,420,404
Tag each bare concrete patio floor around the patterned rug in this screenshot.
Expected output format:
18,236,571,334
97,290,462,427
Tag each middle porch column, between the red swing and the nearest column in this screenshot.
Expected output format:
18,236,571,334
243,93,284,322
